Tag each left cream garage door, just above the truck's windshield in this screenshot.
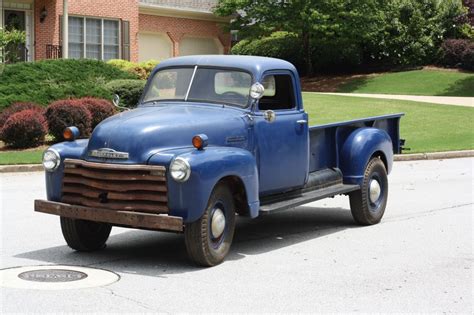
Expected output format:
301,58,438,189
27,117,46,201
138,33,173,61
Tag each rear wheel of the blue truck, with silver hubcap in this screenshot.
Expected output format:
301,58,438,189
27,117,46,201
349,157,388,225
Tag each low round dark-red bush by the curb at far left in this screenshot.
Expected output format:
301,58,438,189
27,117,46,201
0,109,48,148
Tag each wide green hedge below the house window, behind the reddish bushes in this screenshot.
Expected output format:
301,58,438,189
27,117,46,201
0,59,137,110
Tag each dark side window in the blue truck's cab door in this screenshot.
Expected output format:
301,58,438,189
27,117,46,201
259,74,296,110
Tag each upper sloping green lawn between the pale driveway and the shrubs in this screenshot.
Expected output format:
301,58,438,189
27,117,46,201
338,69,474,97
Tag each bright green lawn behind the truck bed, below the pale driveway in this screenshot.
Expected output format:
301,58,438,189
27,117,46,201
303,93,474,153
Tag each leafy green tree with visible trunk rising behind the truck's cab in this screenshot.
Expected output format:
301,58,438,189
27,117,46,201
215,0,384,75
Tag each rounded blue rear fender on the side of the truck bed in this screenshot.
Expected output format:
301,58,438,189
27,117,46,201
339,128,393,185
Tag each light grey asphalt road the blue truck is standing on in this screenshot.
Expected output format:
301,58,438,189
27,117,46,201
0,158,474,314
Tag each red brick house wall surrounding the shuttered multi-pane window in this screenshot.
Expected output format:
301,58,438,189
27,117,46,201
35,0,138,61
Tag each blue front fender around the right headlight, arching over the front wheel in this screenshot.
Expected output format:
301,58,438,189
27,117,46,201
149,147,259,223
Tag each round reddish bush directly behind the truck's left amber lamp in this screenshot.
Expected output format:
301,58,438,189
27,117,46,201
46,100,92,141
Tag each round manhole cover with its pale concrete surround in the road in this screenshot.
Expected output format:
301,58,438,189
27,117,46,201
0,265,120,290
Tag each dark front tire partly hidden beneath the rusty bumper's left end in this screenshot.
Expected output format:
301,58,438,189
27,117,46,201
61,217,112,251
